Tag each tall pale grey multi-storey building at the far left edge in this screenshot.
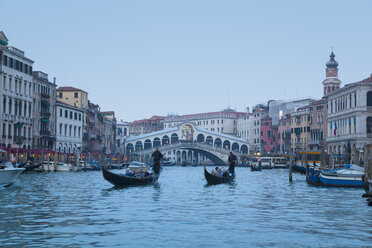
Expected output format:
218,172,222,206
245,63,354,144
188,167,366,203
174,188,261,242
0,31,34,149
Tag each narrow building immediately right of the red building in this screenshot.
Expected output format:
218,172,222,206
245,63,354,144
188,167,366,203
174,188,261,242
278,114,291,154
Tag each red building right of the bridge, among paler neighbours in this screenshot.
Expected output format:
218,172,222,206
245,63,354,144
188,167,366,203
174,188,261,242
260,117,279,154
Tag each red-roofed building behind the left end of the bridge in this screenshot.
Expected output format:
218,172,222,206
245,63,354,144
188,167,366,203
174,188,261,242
129,115,165,136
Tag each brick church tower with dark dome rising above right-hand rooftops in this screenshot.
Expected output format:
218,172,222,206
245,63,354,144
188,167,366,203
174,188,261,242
323,51,341,96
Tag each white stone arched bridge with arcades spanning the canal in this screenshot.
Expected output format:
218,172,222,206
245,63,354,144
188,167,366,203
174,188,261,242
125,123,249,164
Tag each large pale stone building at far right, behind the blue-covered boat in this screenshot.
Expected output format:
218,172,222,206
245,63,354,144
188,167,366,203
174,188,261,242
327,75,372,162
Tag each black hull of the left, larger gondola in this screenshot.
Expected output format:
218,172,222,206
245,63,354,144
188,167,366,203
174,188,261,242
102,168,159,187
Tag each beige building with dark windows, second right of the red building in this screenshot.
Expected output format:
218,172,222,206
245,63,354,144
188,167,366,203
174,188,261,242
291,105,312,153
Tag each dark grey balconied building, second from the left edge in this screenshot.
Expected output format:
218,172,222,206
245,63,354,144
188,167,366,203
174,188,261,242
32,71,56,150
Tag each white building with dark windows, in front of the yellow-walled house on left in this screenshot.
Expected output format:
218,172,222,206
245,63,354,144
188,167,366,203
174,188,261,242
56,101,84,153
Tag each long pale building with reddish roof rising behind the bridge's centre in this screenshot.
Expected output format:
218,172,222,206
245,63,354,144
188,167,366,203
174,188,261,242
163,109,246,136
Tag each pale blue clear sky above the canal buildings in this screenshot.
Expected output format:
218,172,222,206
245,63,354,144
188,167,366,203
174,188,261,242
0,0,372,121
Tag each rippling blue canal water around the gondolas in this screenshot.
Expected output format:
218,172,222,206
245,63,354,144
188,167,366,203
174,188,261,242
0,167,372,247
